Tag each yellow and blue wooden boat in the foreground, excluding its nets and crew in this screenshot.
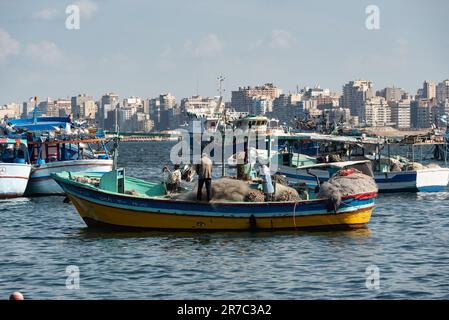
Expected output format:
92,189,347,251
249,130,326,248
52,170,377,231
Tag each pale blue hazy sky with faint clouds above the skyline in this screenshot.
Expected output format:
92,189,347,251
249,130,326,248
0,0,449,105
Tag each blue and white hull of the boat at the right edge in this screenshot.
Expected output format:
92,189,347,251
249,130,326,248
278,166,449,193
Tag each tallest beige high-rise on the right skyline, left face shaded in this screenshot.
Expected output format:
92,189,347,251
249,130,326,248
340,80,373,116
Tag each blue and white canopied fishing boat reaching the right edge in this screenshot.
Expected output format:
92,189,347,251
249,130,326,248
278,134,449,193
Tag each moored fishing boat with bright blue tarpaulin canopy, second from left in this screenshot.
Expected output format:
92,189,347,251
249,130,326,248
7,102,113,196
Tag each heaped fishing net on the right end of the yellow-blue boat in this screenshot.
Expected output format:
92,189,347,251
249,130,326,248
317,169,378,212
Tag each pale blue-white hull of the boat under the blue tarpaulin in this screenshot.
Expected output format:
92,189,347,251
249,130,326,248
26,159,113,196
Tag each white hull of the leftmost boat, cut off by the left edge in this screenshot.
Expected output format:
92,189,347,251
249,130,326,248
0,162,31,199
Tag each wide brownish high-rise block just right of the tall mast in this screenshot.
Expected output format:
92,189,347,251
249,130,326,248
231,83,281,112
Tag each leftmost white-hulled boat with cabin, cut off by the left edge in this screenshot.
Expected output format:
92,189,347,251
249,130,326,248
0,138,31,199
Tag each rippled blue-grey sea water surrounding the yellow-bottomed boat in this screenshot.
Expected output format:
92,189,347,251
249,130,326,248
0,142,449,299
